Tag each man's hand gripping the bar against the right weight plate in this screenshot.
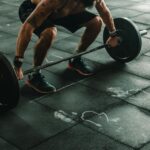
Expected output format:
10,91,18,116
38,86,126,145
106,36,120,47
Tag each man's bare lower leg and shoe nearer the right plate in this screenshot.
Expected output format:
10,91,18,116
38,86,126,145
69,16,102,76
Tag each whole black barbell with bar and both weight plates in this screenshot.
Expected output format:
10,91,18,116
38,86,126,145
0,18,147,112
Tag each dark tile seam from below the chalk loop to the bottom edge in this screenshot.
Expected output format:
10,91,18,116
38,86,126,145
81,123,135,150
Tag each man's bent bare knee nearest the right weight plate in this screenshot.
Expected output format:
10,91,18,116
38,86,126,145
86,16,103,32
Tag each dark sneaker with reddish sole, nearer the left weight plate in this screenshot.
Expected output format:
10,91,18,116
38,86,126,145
26,73,56,93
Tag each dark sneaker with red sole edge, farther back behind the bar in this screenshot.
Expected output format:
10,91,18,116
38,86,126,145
68,57,94,76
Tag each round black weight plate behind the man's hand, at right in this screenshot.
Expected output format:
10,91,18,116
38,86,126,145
103,18,142,63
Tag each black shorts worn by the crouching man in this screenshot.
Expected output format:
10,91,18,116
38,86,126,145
19,0,96,36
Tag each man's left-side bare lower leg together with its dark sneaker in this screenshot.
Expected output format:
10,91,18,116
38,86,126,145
27,27,57,93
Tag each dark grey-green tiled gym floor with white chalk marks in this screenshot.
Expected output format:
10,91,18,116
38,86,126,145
0,0,150,150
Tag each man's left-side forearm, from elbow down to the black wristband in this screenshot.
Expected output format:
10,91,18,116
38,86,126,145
16,23,33,57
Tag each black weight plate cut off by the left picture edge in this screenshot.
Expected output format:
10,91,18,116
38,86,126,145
0,53,20,111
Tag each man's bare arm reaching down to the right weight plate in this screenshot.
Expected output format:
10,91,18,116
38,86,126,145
96,0,116,32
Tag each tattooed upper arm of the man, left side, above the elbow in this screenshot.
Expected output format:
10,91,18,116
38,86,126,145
26,1,52,28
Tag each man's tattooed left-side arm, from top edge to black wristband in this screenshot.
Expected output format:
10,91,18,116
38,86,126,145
16,0,58,57
